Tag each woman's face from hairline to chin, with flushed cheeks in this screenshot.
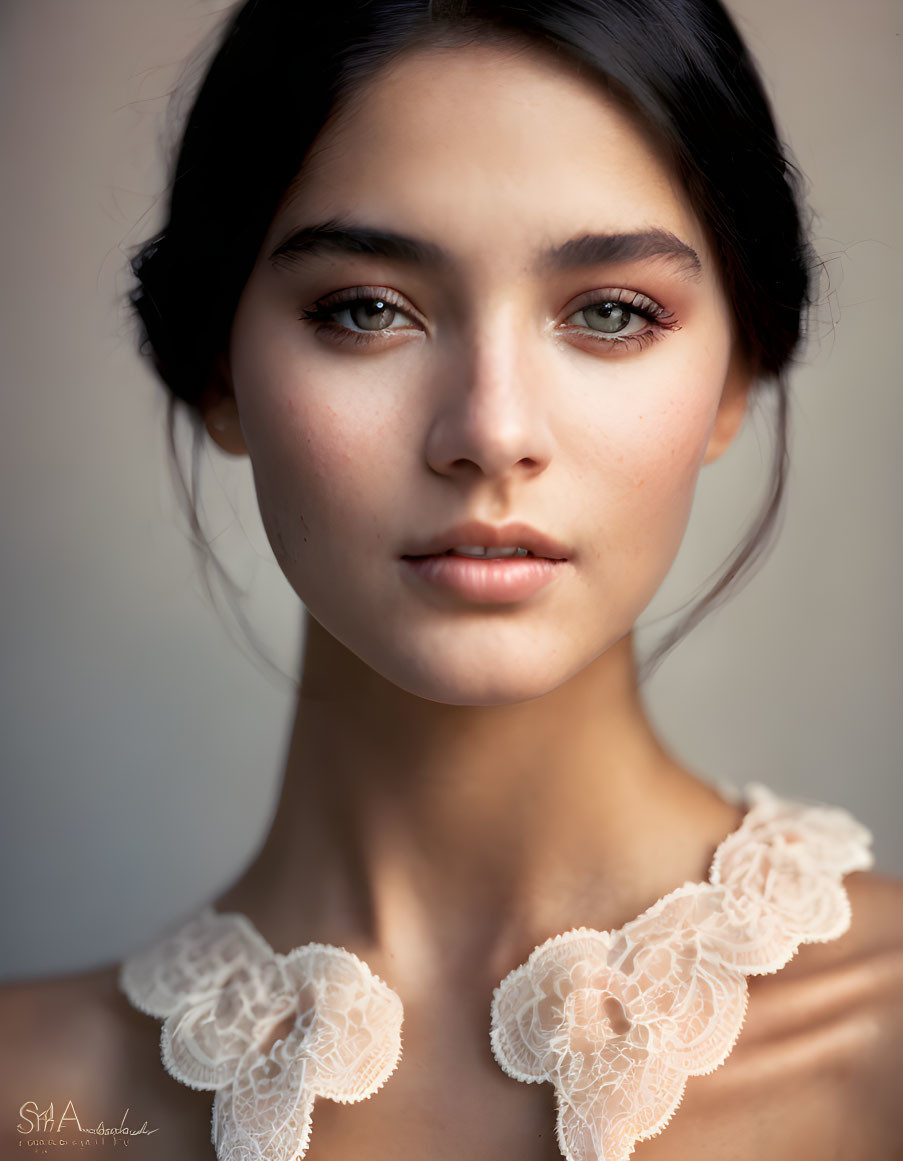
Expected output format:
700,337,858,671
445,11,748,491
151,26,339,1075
221,40,747,705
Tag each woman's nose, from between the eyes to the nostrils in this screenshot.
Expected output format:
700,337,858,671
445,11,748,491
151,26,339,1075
425,312,552,482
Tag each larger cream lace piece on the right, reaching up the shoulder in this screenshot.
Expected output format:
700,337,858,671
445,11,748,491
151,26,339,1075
490,783,873,1161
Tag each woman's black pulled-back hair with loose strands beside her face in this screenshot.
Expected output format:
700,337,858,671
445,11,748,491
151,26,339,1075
131,0,811,677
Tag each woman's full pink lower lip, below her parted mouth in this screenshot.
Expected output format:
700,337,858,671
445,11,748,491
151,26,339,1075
402,555,568,605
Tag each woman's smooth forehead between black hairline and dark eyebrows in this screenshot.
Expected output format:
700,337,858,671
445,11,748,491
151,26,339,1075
270,44,706,271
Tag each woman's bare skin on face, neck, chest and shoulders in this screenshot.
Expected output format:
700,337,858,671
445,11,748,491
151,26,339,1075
0,38,903,1161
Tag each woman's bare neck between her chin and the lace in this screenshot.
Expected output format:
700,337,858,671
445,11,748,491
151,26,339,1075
217,618,739,986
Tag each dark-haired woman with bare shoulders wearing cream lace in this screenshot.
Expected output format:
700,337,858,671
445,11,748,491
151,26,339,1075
5,0,903,1161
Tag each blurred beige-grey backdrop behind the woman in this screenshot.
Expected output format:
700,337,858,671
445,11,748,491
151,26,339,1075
0,0,903,978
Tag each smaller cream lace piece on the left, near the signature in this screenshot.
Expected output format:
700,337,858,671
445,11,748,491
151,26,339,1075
120,907,403,1161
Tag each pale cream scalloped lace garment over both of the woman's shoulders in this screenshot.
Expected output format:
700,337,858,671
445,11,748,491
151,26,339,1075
120,783,873,1161
